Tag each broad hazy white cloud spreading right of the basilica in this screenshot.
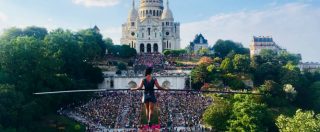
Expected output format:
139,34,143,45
181,3,320,61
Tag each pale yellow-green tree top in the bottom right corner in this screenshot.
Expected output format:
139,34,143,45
276,109,320,132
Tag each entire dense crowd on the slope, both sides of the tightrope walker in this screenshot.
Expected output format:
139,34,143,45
61,91,212,131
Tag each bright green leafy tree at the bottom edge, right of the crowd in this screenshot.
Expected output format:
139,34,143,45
203,95,272,131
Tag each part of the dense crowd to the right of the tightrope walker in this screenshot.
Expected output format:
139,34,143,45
158,91,212,127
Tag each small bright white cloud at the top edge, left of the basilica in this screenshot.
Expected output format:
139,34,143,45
72,0,120,7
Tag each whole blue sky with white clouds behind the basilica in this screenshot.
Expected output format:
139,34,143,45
0,0,320,62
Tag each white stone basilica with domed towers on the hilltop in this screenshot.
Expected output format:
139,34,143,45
120,0,180,53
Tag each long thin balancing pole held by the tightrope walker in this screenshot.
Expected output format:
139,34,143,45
33,89,263,95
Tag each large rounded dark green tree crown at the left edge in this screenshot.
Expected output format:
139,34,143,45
0,37,60,95
